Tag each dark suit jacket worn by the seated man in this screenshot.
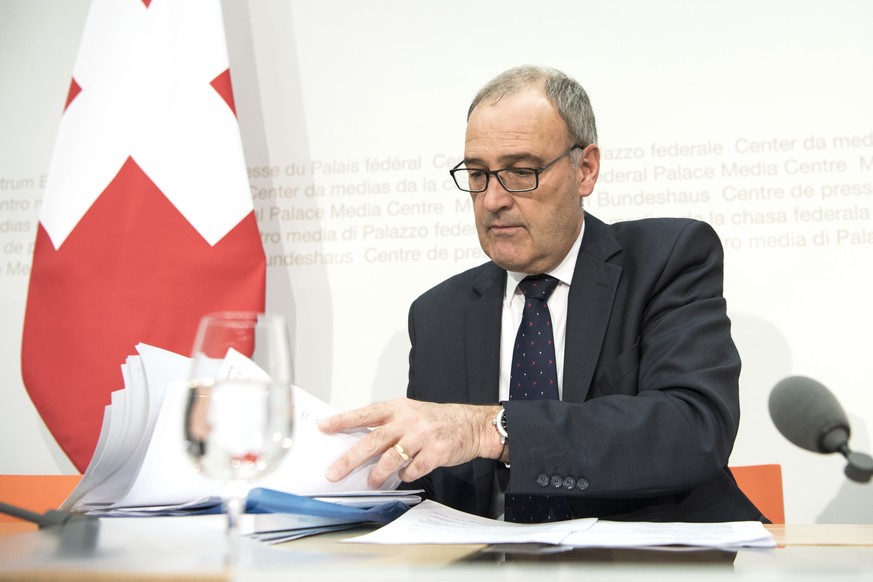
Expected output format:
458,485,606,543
408,214,766,522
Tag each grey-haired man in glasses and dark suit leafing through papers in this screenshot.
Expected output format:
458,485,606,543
321,67,766,521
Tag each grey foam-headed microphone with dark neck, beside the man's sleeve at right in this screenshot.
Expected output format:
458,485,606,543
769,376,873,483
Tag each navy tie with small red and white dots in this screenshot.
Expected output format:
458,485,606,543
504,275,571,523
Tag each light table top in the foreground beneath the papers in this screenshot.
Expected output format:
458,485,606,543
0,516,873,582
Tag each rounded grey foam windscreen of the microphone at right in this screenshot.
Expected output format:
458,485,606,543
769,376,849,453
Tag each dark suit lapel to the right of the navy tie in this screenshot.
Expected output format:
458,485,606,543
562,213,622,402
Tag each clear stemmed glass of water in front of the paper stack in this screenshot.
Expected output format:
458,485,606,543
185,312,293,562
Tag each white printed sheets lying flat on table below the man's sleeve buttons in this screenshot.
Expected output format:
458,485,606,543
344,501,776,548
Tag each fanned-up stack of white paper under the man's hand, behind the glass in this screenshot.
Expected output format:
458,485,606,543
62,344,417,511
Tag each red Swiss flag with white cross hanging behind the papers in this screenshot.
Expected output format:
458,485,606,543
21,0,266,471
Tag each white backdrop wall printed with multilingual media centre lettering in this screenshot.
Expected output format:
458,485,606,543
0,0,873,523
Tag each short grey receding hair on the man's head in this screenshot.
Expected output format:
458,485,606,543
467,65,597,146
